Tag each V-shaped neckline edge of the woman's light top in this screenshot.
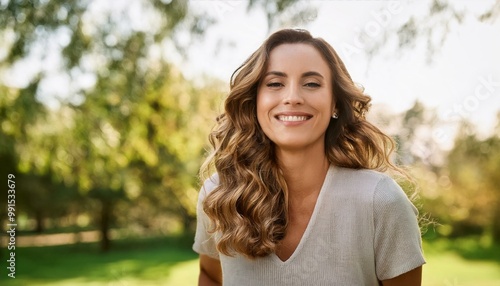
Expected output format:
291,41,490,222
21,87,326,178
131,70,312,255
271,165,334,265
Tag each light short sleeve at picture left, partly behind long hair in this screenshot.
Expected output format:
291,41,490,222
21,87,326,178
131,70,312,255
193,175,219,259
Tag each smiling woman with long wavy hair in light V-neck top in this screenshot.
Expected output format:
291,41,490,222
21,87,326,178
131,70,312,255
193,29,425,286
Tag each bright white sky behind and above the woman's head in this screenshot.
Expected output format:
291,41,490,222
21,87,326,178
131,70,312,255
181,0,500,144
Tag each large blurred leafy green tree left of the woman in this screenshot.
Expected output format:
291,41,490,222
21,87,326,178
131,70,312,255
0,0,308,251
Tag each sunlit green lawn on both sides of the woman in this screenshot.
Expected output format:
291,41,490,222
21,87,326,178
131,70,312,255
0,236,500,286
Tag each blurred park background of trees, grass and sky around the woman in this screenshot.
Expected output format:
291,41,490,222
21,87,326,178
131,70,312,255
0,0,500,285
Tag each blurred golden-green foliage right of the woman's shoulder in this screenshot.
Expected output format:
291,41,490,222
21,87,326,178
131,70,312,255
372,102,500,242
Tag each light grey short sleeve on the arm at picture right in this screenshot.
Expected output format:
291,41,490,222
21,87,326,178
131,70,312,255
373,177,425,280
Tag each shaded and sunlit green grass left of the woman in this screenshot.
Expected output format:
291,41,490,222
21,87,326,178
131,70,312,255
0,237,198,286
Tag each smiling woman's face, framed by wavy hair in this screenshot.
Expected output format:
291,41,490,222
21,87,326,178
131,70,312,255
257,44,335,150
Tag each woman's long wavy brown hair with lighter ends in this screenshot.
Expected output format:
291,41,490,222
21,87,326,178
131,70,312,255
202,29,398,258
